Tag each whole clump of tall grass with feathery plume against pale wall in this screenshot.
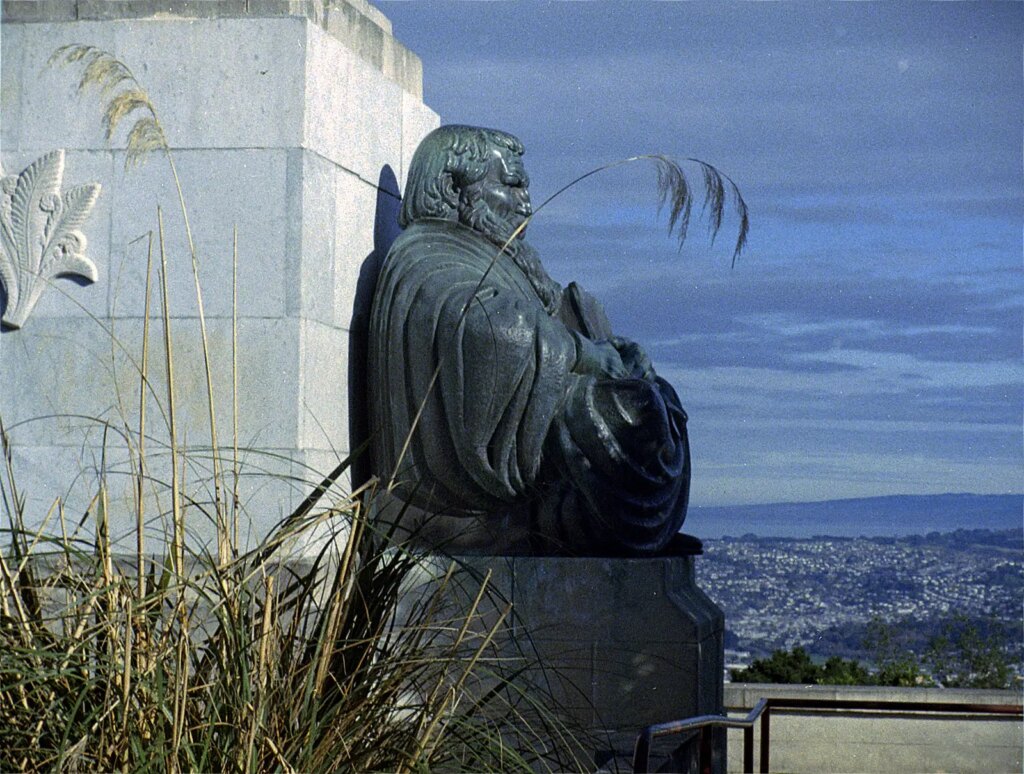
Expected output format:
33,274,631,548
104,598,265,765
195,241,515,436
0,46,583,772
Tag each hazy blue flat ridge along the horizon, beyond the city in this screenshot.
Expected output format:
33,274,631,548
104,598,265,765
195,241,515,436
683,495,1024,540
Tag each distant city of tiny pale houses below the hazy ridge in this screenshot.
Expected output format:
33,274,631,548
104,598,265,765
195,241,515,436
686,496,1024,674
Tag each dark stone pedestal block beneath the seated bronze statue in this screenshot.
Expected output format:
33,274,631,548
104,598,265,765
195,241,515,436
459,541,725,771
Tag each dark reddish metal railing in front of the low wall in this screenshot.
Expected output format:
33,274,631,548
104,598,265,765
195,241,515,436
633,698,1024,774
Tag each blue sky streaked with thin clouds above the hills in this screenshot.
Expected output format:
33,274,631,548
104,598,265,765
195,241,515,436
374,0,1024,506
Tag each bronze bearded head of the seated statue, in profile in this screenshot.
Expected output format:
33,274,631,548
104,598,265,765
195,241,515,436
398,125,531,244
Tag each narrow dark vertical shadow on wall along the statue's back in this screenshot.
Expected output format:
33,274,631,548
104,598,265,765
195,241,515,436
348,165,401,488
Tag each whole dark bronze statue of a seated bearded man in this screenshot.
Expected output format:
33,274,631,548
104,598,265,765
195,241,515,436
368,126,690,556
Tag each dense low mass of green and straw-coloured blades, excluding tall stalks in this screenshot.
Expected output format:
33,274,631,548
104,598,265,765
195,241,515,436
0,434,577,771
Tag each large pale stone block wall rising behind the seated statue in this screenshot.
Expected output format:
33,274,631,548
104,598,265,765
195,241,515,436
0,0,438,539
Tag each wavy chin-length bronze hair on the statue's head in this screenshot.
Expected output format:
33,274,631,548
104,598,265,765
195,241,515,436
398,124,523,228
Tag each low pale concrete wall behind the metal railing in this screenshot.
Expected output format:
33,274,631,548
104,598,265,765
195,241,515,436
725,683,1024,774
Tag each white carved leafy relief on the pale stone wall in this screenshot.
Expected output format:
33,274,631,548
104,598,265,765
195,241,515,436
0,151,100,329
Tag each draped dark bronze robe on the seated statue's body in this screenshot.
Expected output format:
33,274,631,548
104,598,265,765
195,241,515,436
368,219,689,554
